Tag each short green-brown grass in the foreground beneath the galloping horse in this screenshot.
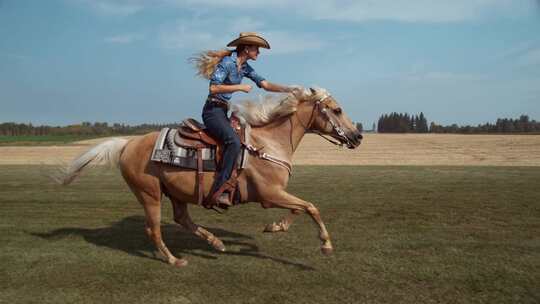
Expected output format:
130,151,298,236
0,166,540,303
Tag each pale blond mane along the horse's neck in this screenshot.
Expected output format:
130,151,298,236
232,88,329,127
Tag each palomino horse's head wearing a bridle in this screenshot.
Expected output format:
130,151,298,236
294,88,362,149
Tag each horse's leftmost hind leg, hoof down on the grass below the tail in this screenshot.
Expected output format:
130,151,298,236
132,187,187,267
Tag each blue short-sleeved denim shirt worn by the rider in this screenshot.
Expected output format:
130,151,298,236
210,52,265,101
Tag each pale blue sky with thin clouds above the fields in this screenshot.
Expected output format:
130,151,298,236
0,0,540,128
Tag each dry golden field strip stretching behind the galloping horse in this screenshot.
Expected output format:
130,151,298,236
0,134,540,166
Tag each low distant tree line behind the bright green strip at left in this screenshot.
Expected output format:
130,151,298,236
0,122,178,136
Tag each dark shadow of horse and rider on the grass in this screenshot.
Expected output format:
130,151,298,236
29,215,315,270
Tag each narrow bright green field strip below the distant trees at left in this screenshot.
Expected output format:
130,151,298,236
0,135,107,146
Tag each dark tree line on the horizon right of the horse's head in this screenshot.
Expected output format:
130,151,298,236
377,112,540,134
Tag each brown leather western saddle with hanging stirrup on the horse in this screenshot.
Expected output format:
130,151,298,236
174,115,245,209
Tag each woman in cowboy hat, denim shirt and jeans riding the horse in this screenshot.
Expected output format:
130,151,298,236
196,32,294,208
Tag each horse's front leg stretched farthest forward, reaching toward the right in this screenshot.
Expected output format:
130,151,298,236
262,190,334,254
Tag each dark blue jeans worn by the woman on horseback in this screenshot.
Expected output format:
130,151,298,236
202,102,242,193
